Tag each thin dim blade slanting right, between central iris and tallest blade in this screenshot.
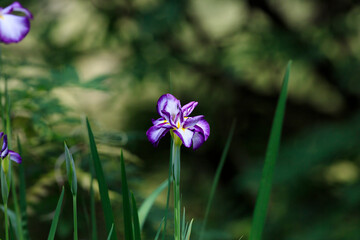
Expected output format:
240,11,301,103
199,120,236,240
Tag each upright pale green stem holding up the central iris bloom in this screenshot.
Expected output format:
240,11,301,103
172,136,181,240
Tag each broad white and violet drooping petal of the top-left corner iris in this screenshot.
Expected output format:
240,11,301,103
0,14,30,44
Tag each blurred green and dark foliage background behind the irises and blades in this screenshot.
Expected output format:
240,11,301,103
0,0,360,240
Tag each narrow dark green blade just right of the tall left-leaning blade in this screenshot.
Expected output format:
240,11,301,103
120,151,133,240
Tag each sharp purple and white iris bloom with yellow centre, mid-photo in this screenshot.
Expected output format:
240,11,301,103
146,93,210,150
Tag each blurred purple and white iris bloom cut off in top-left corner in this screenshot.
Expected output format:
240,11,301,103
0,2,33,44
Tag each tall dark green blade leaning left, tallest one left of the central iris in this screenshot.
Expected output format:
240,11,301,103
86,119,117,240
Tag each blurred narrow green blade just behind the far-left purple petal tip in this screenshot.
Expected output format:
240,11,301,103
17,138,29,240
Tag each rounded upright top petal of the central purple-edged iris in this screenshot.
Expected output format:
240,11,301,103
156,93,181,123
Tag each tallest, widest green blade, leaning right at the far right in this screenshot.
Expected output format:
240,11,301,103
250,61,291,240
